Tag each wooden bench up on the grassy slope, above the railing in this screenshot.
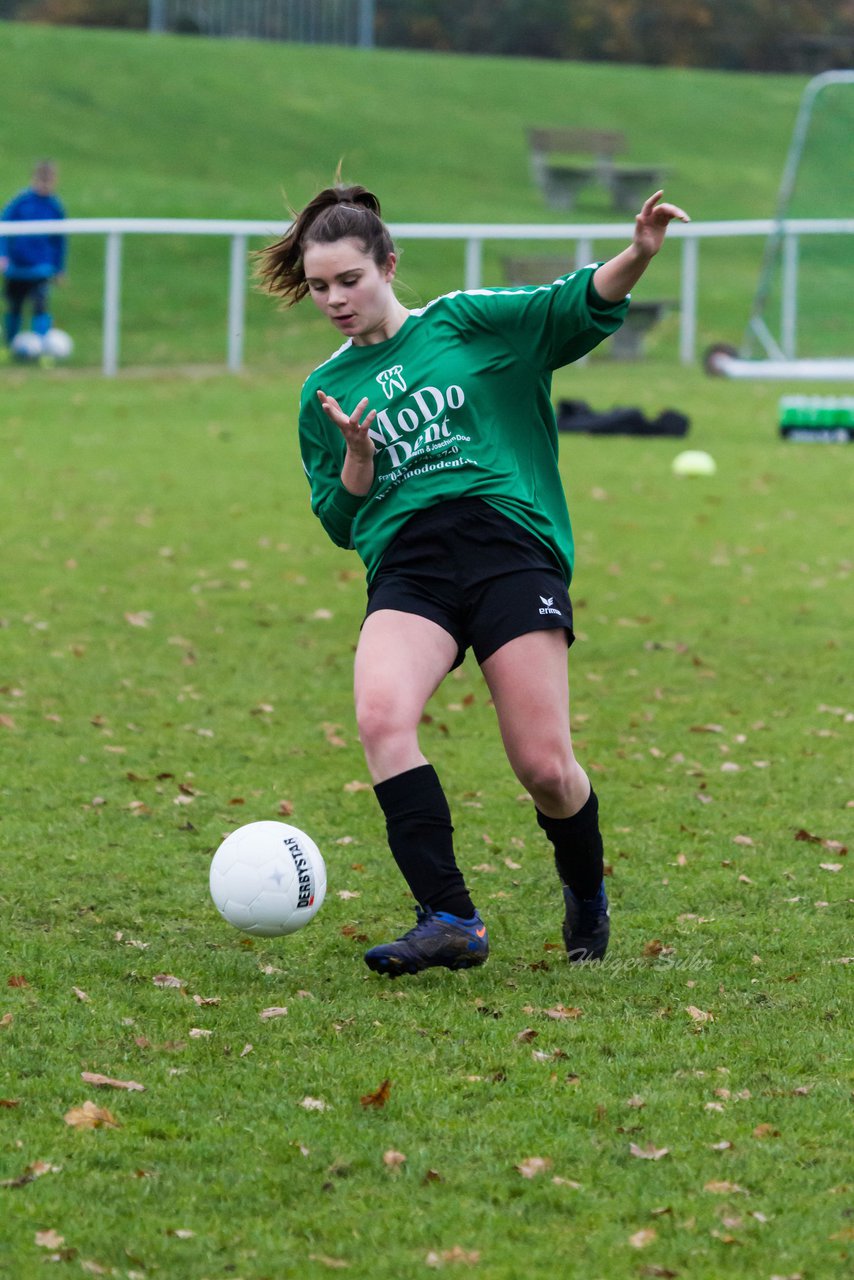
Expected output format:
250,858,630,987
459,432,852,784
526,128,666,214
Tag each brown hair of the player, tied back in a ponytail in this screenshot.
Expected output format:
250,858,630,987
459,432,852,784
257,184,394,306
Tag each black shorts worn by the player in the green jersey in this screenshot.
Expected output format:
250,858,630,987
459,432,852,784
366,498,575,667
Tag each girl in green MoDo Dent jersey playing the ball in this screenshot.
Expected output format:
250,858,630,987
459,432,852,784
261,186,688,978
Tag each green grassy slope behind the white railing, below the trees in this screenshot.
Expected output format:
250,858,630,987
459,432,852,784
0,23,804,361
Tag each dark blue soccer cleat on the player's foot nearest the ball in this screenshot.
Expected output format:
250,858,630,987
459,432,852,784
365,908,489,978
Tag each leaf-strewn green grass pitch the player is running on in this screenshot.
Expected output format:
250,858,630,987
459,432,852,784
0,364,854,1280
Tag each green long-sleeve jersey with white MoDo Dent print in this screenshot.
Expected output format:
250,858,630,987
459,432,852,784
300,264,629,582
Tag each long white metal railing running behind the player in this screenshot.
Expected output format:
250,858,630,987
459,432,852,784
0,218,854,376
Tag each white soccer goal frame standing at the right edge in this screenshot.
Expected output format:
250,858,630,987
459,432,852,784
705,70,854,381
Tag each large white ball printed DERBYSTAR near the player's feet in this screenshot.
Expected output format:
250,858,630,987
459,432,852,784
210,822,326,938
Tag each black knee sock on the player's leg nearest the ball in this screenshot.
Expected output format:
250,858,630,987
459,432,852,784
374,764,475,920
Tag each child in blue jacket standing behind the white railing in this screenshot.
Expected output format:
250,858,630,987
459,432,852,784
0,160,67,346
